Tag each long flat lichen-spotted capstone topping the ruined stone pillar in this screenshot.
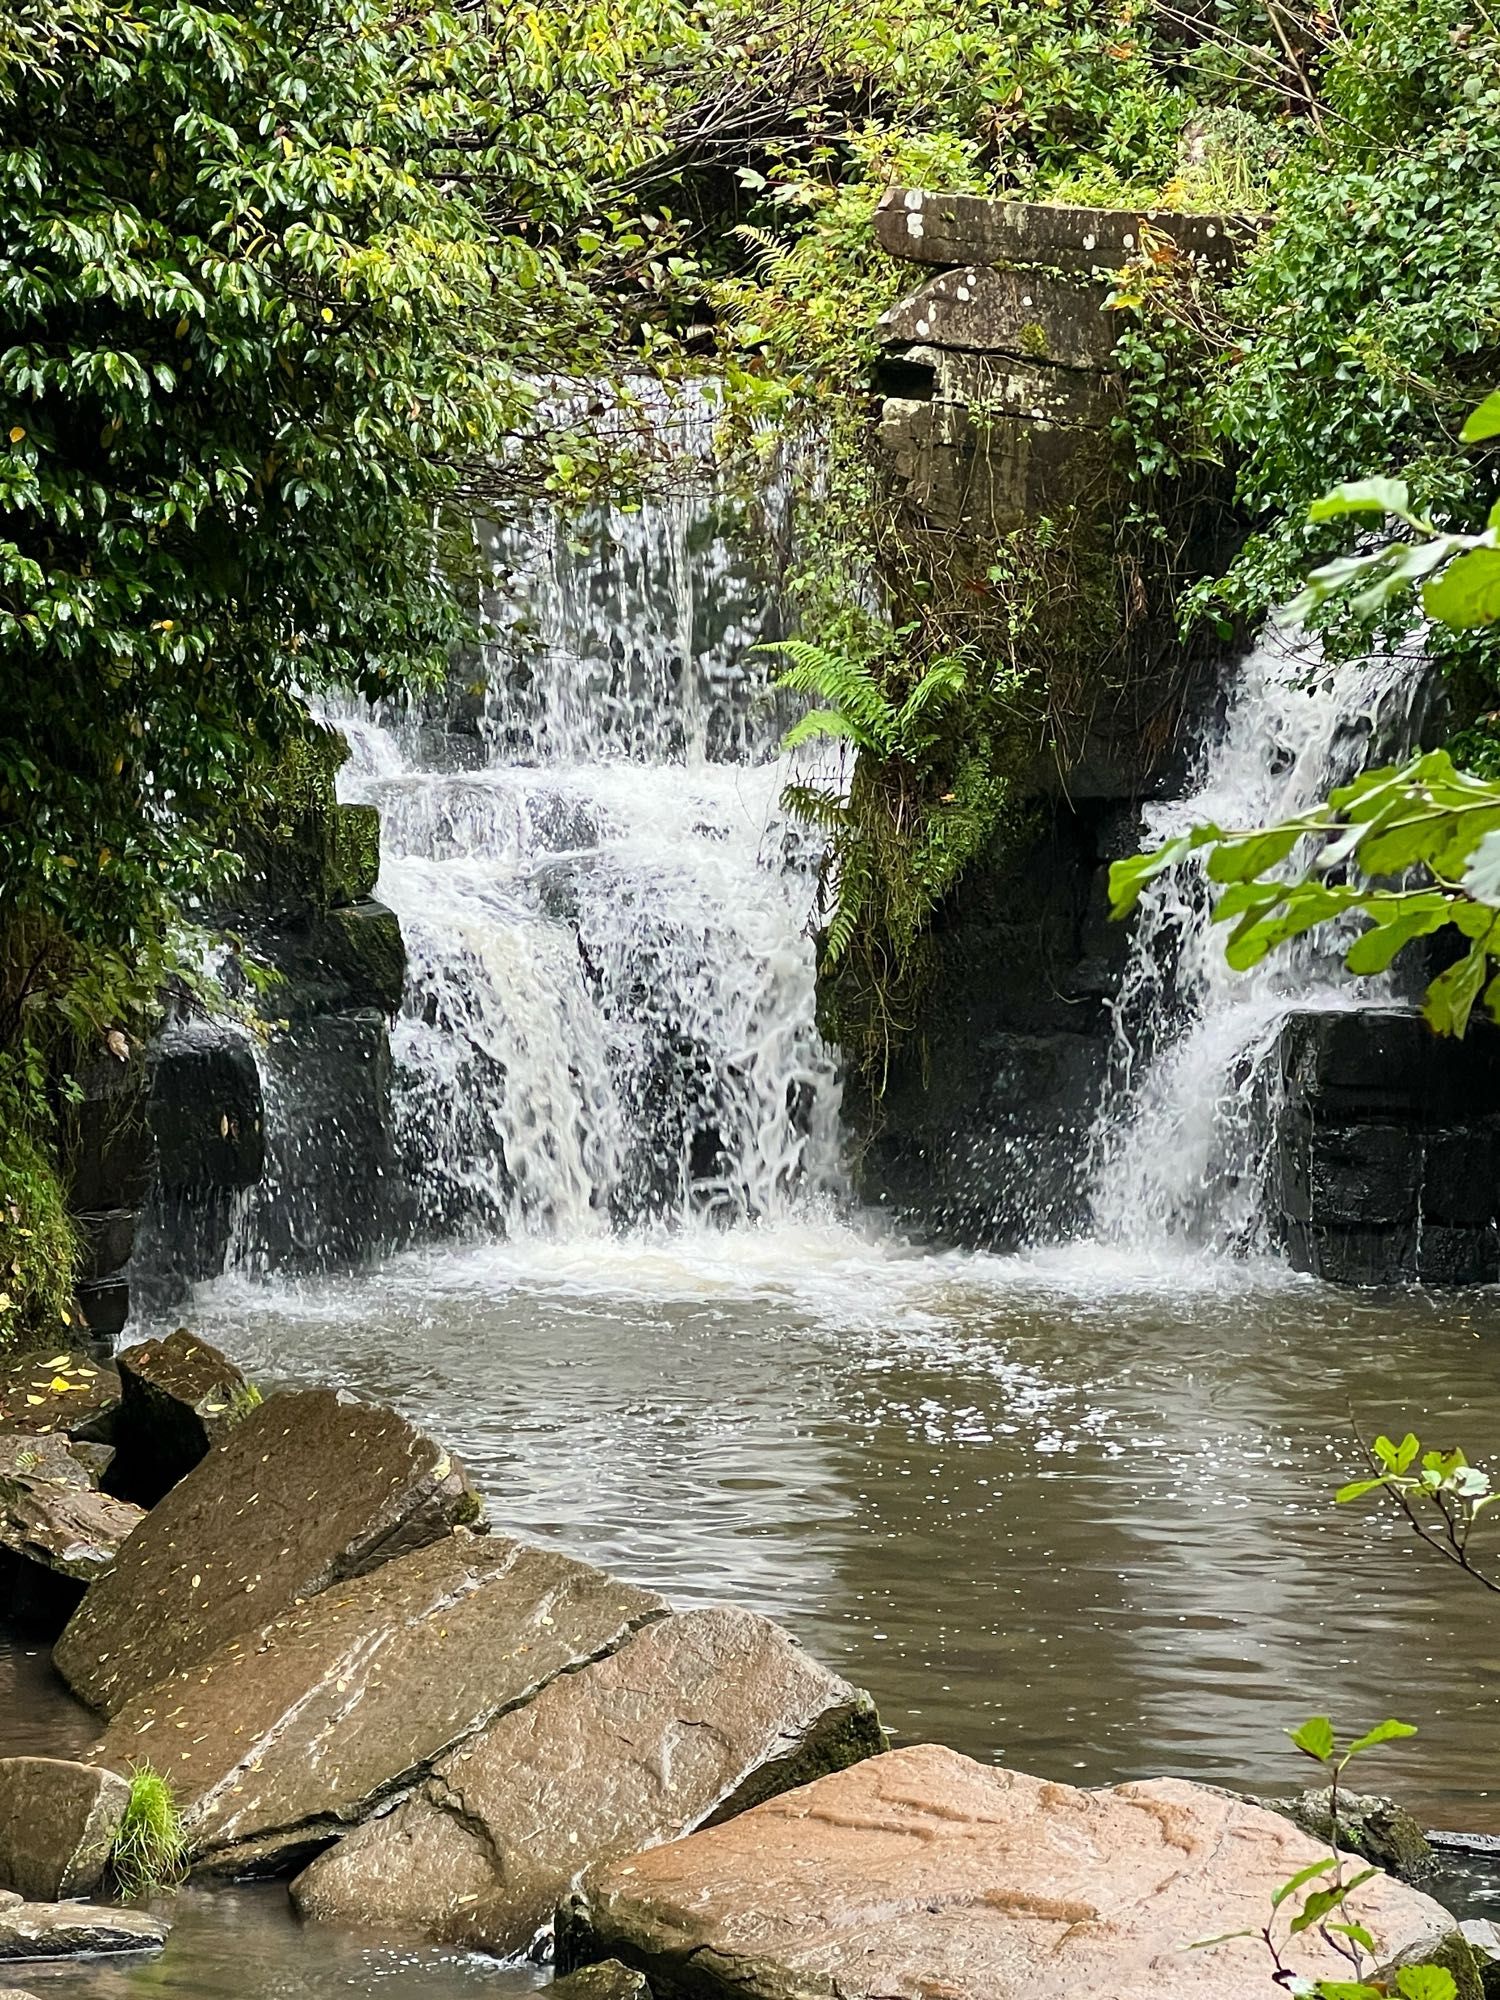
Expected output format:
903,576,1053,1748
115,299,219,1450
876,188,1256,274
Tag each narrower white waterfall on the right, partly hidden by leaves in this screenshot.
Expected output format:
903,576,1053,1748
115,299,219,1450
1090,624,1422,1254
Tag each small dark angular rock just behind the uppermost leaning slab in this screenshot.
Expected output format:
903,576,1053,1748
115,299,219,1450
110,1326,260,1506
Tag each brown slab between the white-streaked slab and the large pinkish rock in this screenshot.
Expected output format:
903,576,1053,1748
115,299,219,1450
292,1610,884,1954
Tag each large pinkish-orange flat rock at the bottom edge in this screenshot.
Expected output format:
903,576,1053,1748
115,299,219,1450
558,1744,1462,2000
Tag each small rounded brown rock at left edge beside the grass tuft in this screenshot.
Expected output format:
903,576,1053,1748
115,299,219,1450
0,1756,130,1902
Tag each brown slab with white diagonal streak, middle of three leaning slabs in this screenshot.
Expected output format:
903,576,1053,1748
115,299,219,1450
96,1532,666,1874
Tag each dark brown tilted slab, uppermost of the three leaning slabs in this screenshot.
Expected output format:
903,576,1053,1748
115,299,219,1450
54,1388,478,1714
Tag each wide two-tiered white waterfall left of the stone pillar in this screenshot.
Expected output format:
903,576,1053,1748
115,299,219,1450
338,394,838,1236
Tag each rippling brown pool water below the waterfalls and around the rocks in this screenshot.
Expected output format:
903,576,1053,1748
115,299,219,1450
0,1218,1500,2000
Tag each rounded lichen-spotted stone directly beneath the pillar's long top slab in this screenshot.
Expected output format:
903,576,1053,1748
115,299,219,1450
880,264,1120,370
